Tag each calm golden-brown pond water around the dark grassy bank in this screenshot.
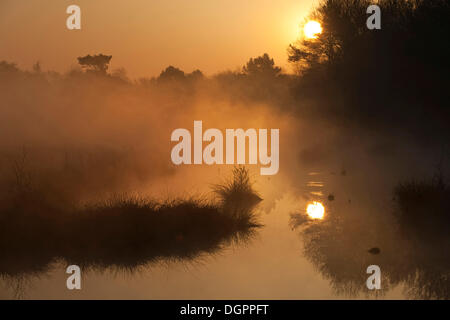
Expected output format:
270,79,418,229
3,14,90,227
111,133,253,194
0,131,449,299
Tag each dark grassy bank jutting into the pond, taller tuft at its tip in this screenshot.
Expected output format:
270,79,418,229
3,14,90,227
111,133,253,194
0,169,259,277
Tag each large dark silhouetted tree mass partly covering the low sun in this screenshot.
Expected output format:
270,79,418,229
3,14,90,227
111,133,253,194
288,0,450,138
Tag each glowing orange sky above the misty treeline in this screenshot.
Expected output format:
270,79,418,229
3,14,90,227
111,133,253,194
0,0,317,77
